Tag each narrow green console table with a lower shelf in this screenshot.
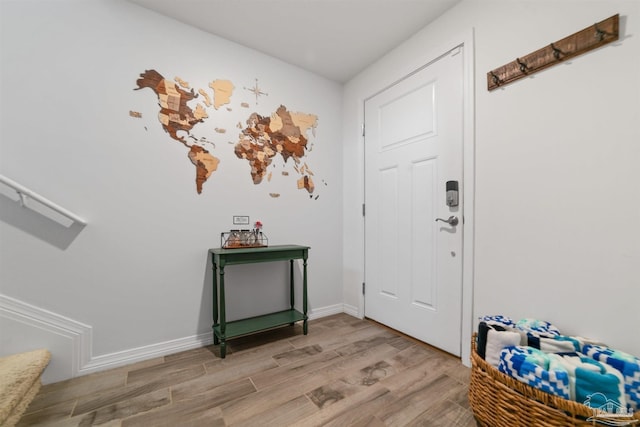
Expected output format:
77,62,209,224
209,245,309,359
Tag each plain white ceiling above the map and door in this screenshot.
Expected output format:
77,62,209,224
130,0,460,82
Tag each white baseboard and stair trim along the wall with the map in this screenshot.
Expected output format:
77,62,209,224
0,294,358,383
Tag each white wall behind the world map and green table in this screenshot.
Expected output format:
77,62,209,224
0,0,342,381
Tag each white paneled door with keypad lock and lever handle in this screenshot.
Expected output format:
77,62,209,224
365,47,464,356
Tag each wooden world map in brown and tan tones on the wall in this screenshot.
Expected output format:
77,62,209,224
129,69,320,200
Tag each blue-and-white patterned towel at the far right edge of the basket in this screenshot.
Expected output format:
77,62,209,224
582,344,640,412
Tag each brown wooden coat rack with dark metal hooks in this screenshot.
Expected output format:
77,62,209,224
487,14,619,91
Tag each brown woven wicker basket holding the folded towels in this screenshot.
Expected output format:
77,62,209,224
469,334,640,427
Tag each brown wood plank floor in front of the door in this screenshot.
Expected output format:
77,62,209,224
18,314,476,427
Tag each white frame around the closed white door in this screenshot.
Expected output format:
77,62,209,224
358,29,475,366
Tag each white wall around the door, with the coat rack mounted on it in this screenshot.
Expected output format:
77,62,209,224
343,0,640,355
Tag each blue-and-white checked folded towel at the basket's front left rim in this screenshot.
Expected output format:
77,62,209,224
498,346,570,399
